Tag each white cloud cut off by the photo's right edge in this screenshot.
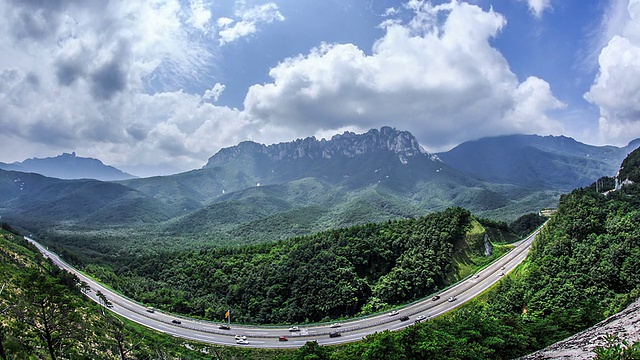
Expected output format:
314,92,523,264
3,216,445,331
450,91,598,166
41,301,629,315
585,0,640,144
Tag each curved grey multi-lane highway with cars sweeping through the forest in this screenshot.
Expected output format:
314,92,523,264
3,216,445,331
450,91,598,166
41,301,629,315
25,229,540,348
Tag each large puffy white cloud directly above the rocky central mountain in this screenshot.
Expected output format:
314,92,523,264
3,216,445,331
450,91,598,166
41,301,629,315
245,1,562,150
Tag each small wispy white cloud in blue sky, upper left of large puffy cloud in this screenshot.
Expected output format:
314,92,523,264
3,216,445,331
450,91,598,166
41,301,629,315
217,3,284,45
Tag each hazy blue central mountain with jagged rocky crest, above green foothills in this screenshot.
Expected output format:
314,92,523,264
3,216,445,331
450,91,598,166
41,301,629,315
124,127,443,208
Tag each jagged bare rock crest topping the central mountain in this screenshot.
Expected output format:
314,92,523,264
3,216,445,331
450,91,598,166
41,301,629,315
205,126,431,168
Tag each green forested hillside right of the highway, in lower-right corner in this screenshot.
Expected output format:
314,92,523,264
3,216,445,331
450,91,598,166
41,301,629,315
316,150,640,360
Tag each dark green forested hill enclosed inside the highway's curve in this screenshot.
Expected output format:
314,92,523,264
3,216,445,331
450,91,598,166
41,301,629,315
87,208,510,324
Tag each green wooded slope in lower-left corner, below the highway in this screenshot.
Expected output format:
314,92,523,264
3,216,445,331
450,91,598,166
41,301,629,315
0,228,225,360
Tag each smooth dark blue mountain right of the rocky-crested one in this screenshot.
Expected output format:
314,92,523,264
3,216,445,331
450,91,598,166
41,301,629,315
437,135,640,191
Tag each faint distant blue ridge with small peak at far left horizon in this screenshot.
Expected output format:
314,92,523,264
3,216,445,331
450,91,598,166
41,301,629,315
0,151,135,181
